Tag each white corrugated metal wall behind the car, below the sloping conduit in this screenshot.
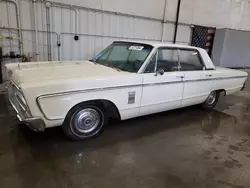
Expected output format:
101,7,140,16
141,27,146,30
0,1,191,61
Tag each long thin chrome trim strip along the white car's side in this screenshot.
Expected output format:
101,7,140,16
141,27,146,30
36,76,247,121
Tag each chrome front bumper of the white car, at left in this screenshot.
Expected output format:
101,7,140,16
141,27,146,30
8,86,45,132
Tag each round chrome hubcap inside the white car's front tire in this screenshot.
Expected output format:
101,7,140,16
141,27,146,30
73,108,100,133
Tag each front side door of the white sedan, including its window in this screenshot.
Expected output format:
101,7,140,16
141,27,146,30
139,48,184,116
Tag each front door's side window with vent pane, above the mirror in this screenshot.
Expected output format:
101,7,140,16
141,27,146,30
145,48,178,73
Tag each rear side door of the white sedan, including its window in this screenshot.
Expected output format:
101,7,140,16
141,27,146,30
179,49,213,107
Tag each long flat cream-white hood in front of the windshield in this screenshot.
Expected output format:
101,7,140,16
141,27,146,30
6,61,133,85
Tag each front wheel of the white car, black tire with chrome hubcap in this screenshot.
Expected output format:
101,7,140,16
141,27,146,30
62,103,107,140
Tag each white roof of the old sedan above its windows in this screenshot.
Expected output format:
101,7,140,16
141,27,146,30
114,40,201,50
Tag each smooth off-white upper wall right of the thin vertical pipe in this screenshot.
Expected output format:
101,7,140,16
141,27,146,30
162,0,250,30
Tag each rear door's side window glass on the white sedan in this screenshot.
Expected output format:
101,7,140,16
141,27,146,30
179,50,204,71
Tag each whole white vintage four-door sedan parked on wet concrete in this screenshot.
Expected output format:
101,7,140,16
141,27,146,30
6,41,248,140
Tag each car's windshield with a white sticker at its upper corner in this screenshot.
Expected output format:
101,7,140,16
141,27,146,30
92,42,153,72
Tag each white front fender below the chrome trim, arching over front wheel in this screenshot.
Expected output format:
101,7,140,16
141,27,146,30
36,85,142,121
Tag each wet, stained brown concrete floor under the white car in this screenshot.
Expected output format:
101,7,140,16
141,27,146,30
0,79,250,188
